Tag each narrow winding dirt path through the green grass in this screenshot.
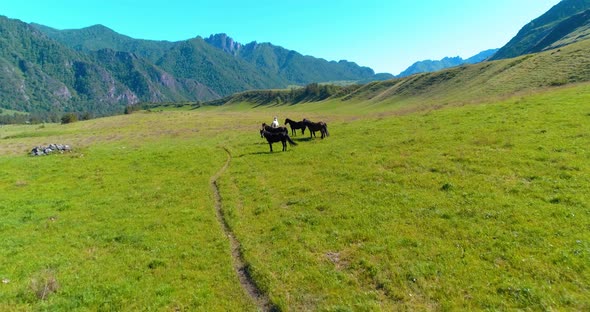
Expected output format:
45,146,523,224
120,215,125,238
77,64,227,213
210,147,278,311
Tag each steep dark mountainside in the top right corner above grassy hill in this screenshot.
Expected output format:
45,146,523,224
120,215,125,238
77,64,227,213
491,0,590,60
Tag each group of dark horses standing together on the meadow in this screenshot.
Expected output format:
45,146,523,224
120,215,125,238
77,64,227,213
260,118,330,152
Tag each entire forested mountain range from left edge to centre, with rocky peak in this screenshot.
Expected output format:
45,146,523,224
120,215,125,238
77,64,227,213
0,16,393,116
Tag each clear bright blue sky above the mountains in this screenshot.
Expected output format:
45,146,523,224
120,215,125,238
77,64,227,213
0,0,559,74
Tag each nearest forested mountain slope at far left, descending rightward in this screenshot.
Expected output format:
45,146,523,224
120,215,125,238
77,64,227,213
0,17,137,114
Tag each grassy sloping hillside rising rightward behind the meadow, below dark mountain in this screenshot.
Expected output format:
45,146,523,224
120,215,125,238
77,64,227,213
212,40,590,110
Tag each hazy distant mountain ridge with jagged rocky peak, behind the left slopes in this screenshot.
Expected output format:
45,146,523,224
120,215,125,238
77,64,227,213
34,24,393,96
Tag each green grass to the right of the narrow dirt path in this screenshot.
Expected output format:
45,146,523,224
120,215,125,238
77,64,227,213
220,85,590,310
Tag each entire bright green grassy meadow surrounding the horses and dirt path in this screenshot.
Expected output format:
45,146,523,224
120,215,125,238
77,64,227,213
0,84,590,311
